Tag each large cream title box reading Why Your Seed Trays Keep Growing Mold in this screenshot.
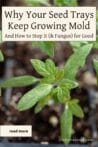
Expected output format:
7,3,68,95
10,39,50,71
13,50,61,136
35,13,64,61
2,7,96,41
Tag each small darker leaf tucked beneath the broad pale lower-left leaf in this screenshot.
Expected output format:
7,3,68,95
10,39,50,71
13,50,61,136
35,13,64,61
35,95,51,113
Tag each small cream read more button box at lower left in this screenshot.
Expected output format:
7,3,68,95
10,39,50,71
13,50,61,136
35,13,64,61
0,125,32,137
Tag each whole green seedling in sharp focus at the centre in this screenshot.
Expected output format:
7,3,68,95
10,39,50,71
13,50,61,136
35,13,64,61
0,44,93,144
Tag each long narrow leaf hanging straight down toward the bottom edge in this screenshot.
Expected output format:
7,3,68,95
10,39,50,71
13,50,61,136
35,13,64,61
60,104,73,144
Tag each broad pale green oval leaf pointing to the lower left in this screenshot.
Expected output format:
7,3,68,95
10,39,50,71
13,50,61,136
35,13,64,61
17,84,52,111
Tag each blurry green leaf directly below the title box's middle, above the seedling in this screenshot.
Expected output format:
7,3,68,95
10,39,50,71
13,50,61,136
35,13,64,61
32,41,54,57
